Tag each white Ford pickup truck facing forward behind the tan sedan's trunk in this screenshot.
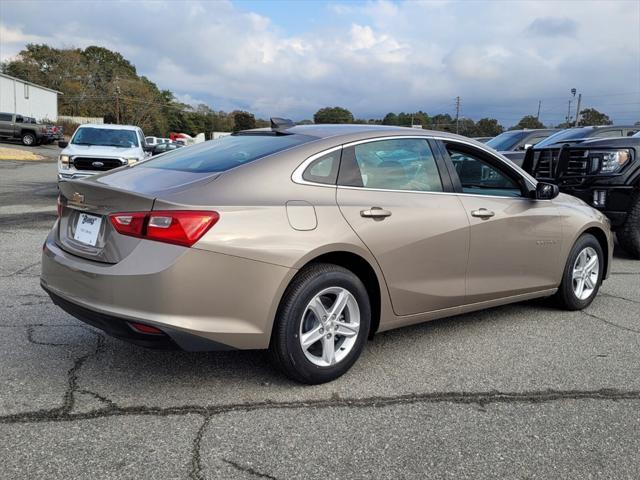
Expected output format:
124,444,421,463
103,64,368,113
58,124,153,180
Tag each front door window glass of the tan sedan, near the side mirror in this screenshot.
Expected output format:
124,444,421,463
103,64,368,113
447,145,522,197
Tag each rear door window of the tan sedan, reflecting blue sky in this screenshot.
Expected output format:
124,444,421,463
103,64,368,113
340,138,443,192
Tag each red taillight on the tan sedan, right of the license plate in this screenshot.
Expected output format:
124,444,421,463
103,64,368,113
109,210,220,247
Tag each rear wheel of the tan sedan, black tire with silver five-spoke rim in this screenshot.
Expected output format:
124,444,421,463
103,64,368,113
269,263,371,385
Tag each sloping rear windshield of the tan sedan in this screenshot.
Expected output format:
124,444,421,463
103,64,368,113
140,134,316,173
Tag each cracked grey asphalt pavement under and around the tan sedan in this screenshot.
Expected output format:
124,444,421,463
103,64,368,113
0,162,640,479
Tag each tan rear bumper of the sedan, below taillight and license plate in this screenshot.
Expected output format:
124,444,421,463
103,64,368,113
41,226,295,351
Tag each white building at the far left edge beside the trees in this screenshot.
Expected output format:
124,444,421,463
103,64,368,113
0,73,62,121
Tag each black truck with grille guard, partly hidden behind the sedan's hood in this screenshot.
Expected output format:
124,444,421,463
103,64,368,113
523,126,640,259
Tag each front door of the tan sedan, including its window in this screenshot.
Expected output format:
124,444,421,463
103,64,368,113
441,141,562,303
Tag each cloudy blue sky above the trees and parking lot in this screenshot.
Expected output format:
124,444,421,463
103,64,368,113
0,0,640,126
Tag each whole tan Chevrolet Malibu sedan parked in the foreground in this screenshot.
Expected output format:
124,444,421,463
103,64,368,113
41,120,613,384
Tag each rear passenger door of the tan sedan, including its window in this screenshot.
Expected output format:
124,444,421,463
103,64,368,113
337,137,469,315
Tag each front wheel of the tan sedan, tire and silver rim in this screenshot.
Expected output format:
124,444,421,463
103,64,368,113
556,233,605,310
